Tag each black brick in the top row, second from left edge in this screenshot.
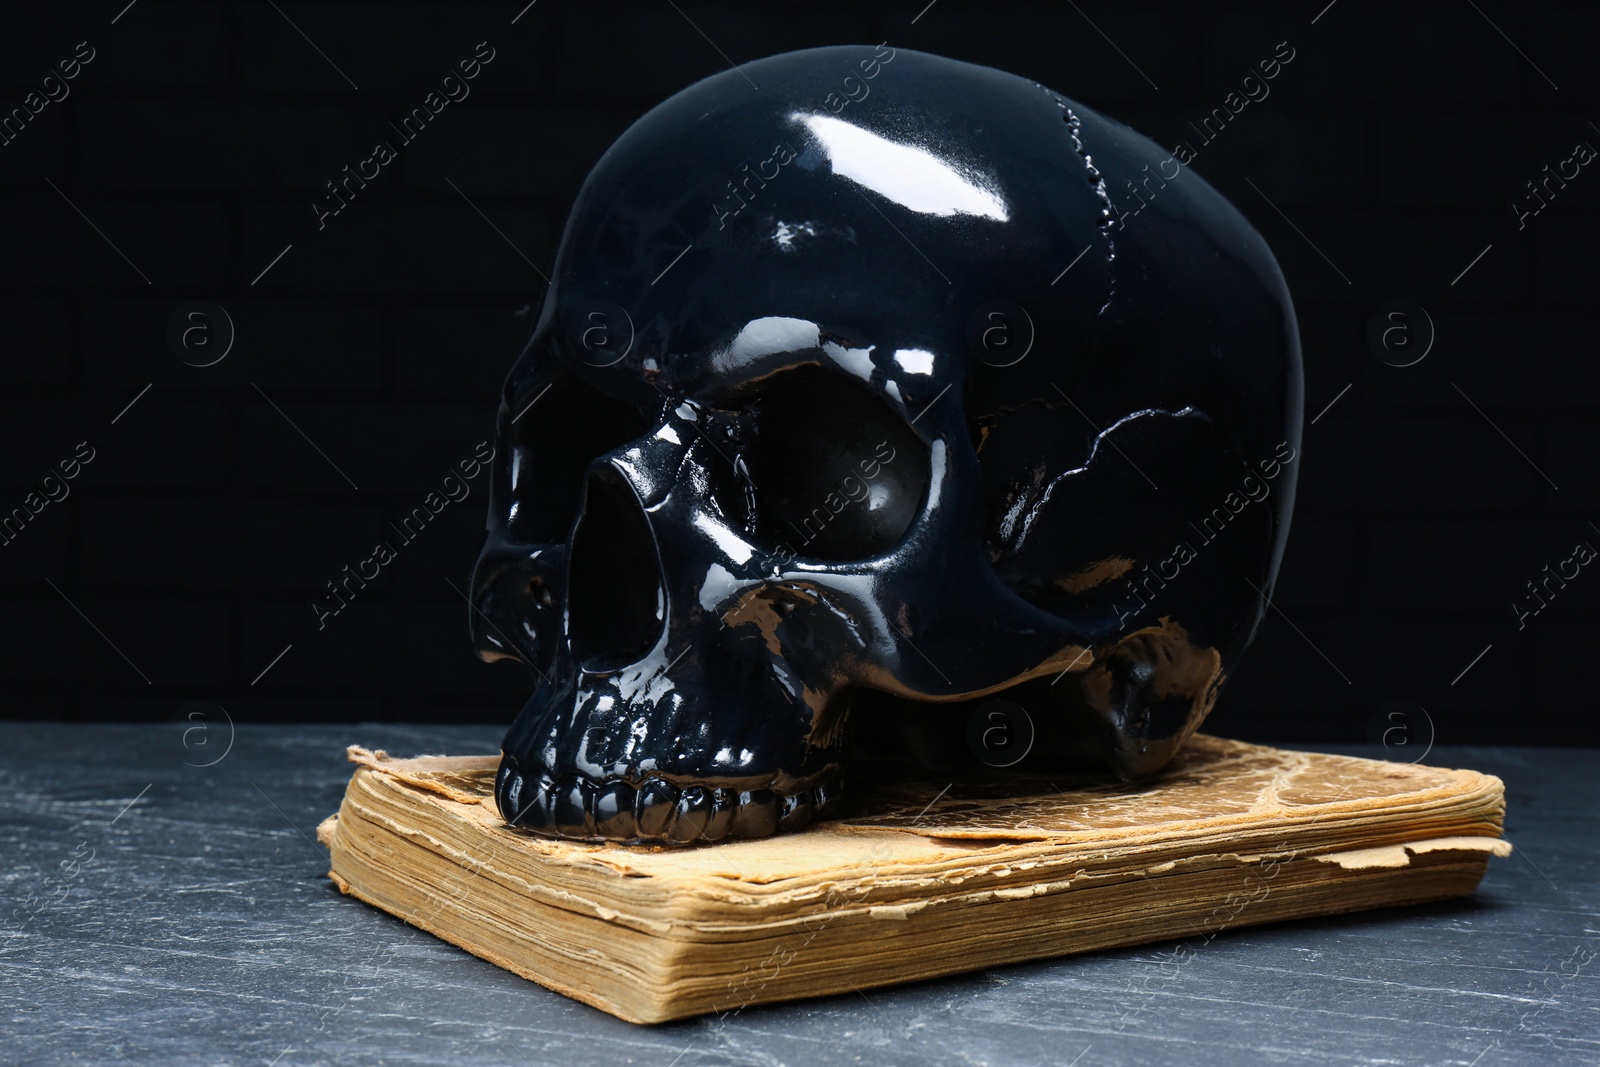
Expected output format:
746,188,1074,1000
240,3,547,94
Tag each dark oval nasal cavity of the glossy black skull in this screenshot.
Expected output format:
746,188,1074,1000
566,467,666,670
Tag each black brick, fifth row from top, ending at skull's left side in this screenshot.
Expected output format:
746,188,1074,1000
238,397,494,499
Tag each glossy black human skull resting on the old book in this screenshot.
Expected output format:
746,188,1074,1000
470,46,1302,843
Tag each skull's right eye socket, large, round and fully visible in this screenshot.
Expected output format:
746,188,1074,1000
746,366,930,560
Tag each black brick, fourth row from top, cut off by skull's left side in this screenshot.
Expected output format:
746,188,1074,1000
395,302,533,396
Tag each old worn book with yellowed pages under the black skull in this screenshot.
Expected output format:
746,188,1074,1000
318,736,1510,1022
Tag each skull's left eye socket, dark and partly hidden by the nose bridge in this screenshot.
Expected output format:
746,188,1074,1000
507,376,650,544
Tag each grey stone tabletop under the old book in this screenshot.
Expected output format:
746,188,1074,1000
0,726,1600,1067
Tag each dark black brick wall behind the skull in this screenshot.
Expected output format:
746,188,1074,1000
0,0,1600,744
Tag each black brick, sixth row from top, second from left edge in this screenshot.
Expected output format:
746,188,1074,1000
82,499,386,591
